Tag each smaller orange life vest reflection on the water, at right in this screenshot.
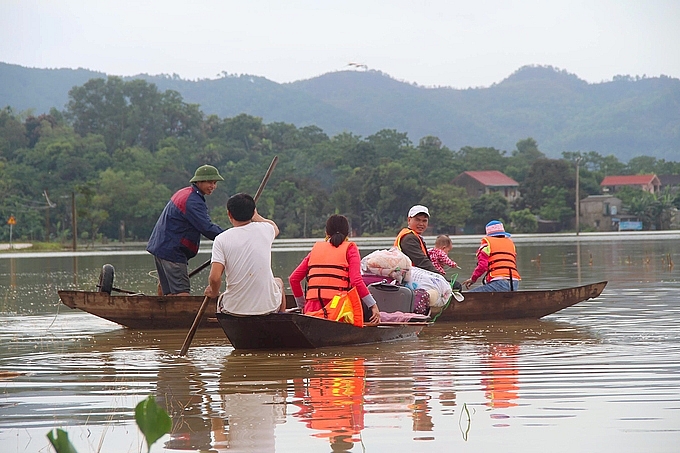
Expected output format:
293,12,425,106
482,344,519,408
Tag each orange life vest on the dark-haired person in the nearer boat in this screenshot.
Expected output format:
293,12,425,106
306,241,356,300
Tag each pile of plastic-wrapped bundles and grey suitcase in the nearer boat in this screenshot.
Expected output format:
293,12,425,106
361,247,452,318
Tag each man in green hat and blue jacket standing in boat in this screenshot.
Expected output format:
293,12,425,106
146,165,224,296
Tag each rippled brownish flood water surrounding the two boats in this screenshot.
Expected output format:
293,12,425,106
0,232,680,453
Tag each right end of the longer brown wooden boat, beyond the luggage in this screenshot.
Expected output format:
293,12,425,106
437,282,607,322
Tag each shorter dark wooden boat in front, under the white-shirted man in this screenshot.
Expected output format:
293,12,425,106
217,313,427,349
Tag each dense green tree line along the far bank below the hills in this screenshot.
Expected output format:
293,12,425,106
0,77,680,242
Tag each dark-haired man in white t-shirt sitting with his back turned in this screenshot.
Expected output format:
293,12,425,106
205,193,285,315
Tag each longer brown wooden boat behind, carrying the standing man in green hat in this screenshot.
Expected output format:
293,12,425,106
59,281,607,330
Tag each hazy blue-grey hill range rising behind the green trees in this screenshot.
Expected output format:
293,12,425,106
0,63,680,161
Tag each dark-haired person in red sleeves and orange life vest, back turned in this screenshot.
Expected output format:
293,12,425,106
288,214,380,324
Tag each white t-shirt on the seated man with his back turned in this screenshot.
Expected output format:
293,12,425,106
211,222,281,315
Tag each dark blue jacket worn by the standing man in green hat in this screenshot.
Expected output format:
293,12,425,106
146,184,224,264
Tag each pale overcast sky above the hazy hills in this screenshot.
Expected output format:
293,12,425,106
0,0,680,88
